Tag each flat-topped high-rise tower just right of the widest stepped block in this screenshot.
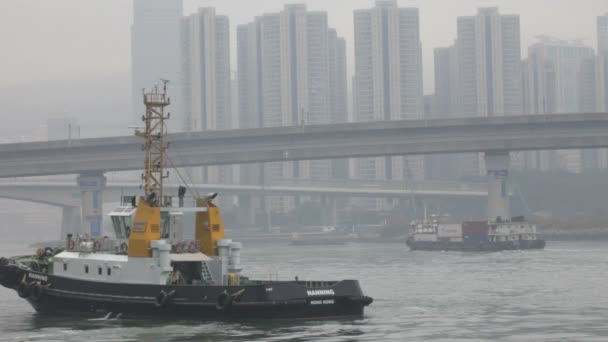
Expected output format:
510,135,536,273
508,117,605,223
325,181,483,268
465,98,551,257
353,0,424,184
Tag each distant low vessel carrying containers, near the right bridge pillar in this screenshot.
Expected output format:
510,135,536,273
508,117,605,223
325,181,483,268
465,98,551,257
406,216,545,252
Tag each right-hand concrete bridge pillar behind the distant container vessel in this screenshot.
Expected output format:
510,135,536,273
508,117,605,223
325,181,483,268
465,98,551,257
485,152,511,221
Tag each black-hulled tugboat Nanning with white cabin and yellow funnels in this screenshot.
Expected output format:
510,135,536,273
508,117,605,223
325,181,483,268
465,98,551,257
0,82,373,320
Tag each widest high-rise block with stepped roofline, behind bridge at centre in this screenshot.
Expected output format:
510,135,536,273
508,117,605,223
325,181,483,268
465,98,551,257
237,4,346,209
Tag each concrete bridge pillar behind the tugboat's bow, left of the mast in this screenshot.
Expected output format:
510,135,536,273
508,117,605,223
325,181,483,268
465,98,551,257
78,171,106,237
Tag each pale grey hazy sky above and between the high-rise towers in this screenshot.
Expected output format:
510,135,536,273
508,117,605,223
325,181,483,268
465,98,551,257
0,0,608,142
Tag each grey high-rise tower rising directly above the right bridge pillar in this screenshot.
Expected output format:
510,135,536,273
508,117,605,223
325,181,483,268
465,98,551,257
457,8,522,116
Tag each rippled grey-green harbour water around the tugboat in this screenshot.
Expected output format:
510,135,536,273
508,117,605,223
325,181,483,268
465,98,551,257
0,236,608,342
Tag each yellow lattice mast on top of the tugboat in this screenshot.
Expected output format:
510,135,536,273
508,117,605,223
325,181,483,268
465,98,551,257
135,80,171,206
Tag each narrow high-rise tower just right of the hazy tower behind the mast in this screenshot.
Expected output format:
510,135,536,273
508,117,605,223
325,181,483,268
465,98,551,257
181,8,233,184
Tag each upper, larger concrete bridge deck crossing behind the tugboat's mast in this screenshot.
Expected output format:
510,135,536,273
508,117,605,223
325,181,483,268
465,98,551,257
0,113,608,178
